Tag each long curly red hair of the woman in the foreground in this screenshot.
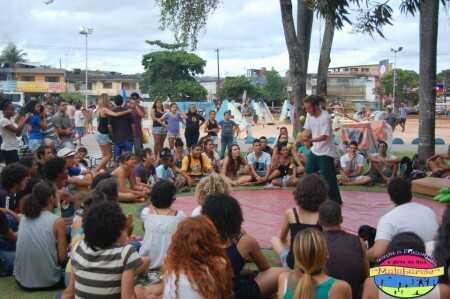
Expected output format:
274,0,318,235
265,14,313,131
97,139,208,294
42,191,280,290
163,215,233,298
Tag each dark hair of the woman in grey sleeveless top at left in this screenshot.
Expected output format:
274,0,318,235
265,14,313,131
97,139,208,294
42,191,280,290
21,181,57,219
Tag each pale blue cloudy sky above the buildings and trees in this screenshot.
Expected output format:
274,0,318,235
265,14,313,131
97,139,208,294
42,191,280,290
0,0,450,77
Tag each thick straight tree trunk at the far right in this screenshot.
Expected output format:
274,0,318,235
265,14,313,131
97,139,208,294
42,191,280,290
418,0,440,166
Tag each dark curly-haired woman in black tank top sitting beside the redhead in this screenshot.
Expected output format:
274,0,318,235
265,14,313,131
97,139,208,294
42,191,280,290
202,193,287,298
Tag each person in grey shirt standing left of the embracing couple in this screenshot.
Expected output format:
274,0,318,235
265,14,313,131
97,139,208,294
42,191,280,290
53,99,74,151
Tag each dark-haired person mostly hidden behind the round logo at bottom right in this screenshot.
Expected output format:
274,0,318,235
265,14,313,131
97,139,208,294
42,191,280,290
362,232,450,299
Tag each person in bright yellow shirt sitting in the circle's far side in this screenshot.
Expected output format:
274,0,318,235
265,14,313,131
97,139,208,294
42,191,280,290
181,144,214,187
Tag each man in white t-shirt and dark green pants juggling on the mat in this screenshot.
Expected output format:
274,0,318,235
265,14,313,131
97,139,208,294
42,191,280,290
303,95,342,204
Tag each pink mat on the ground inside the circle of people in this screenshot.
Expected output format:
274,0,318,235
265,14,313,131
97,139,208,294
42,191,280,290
173,190,446,247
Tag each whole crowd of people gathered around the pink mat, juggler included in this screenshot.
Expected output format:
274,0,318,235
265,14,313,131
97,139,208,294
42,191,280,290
0,94,450,299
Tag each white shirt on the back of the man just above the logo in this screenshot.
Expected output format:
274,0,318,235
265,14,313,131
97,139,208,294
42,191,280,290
375,202,439,242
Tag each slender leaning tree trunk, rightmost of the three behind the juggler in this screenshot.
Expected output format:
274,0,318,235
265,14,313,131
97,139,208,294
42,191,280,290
317,19,334,96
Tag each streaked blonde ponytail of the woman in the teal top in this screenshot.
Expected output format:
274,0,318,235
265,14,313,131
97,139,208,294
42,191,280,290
294,228,328,299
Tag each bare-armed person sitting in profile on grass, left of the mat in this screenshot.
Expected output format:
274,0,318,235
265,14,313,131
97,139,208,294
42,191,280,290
111,152,150,202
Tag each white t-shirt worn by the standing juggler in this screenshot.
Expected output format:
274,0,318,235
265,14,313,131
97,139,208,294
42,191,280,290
304,110,336,158
